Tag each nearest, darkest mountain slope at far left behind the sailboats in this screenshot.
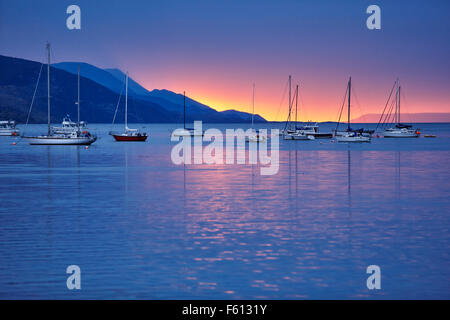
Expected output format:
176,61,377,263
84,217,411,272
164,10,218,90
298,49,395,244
0,56,174,123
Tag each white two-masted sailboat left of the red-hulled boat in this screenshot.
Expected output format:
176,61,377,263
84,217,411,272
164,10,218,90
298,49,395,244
23,42,97,145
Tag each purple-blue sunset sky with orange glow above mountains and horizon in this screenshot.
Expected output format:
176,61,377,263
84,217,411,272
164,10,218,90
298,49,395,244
0,0,450,121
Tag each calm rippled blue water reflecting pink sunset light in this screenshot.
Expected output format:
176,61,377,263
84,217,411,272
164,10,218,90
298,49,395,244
0,124,450,299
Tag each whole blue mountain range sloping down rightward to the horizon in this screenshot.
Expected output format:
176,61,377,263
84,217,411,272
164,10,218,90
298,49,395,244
0,55,265,123
